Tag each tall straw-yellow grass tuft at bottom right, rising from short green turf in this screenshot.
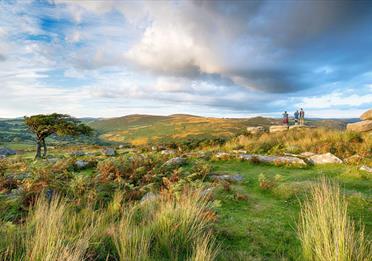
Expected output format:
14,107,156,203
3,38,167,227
298,178,372,261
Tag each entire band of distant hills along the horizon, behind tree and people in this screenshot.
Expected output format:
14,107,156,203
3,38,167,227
0,114,358,145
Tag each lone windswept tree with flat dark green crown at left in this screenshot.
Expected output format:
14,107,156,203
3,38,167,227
25,113,93,159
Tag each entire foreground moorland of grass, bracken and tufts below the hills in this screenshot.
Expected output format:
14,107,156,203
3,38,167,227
0,114,372,261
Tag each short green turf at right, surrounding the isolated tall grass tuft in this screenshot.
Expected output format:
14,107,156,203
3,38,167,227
213,160,372,260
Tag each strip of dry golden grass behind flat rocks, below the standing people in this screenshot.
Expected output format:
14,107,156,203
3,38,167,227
224,128,372,158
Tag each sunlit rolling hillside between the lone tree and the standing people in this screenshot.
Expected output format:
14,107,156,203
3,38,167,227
90,114,279,145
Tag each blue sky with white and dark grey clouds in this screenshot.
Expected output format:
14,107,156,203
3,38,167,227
0,0,372,118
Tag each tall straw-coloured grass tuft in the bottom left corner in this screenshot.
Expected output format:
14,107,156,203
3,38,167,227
0,193,94,261
